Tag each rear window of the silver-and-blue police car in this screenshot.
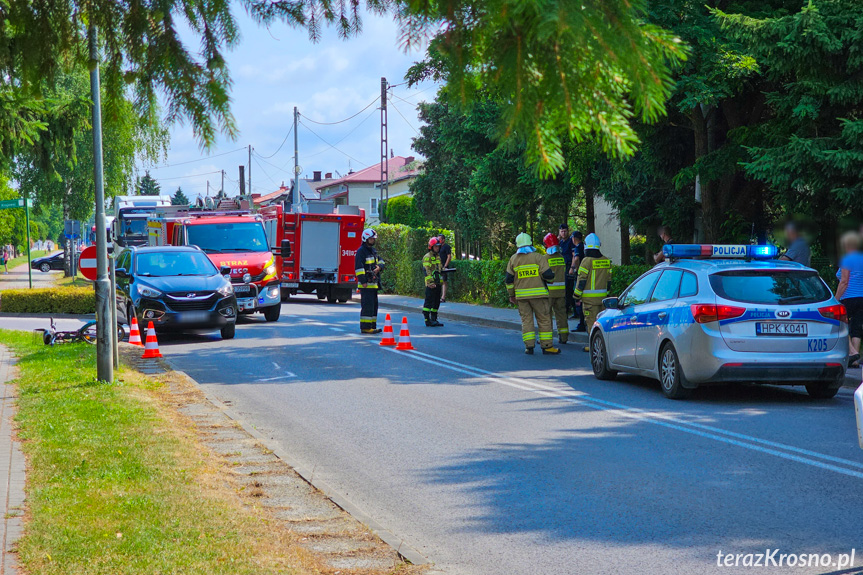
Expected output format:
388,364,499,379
710,270,831,305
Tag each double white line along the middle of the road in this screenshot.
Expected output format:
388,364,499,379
386,348,863,479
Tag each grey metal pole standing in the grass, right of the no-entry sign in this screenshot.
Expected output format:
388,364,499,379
87,24,112,383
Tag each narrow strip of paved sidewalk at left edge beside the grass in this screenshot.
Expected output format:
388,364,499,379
0,346,25,575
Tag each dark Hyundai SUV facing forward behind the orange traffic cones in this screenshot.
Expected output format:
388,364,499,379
116,246,237,339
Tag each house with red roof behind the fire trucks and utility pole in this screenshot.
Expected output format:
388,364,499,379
317,156,422,225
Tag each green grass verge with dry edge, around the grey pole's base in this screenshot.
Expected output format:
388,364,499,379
0,330,317,575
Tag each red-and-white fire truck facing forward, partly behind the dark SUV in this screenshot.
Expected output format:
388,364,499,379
147,202,282,321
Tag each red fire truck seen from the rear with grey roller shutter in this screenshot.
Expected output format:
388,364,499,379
259,200,366,303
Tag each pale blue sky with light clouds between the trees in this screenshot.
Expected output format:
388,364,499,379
146,8,436,199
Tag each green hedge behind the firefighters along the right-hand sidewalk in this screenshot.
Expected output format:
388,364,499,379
368,224,650,307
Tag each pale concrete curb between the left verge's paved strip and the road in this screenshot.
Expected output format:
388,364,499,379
162,358,431,565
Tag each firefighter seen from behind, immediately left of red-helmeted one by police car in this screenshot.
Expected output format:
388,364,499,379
505,232,560,355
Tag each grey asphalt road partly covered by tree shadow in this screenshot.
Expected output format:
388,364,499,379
40,299,863,575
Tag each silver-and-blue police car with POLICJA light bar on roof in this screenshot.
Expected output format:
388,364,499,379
589,244,848,399
